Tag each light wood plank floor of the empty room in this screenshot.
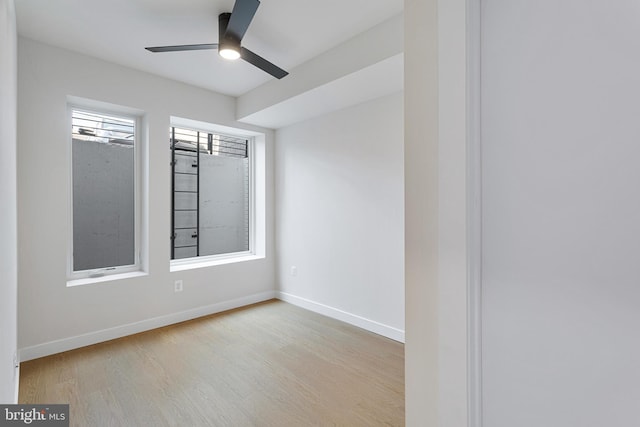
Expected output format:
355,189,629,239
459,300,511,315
19,300,404,427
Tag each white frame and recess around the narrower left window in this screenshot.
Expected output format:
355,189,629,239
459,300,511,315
67,97,144,286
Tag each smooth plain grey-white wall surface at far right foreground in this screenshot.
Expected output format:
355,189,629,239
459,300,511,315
482,0,640,427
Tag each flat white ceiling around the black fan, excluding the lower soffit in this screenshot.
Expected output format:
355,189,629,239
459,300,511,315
16,0,403,97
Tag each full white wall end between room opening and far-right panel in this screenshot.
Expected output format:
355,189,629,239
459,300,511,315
404,0,470,427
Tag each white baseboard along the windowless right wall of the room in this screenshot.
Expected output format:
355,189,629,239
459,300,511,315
277,292,404,343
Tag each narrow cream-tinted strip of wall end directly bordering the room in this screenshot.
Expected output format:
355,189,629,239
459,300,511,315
404,0,438,427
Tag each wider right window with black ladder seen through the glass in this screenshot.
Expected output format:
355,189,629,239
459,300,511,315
169,122,253,260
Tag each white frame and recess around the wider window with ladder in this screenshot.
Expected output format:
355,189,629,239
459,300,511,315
168,116,266,272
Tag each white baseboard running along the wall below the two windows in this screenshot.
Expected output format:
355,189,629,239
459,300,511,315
19,291,278,362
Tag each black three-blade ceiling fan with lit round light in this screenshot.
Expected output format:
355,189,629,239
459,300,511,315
145,0,289,79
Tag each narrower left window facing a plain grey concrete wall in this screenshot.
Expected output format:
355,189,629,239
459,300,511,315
69,107,140,279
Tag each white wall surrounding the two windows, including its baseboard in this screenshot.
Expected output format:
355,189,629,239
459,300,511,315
18,39,275,358
